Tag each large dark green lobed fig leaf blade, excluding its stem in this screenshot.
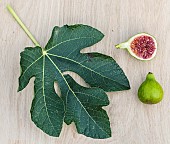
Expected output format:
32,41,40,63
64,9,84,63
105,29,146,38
18,24,130,138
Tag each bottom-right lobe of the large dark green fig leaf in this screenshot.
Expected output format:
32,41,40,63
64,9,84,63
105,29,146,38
65,75,111,139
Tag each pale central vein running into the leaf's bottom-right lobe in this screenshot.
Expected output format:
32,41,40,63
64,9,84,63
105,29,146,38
46,54,109,135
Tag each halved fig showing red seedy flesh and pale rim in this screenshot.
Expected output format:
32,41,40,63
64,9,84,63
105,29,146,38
116,33,157,61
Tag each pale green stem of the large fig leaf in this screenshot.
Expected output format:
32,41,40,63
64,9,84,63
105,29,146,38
7,4,40,47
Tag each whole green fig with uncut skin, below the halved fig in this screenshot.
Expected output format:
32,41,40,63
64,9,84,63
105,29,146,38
138,72,164,104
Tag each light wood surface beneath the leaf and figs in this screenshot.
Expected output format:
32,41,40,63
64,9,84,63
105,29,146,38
0,0,170,144
